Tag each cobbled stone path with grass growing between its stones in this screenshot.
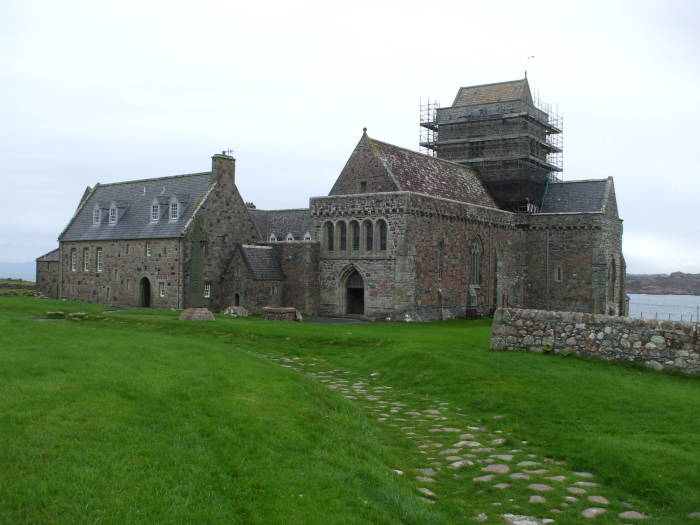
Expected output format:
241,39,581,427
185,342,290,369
268,357,664,525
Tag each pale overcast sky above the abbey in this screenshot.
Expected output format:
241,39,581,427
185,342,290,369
0,0,700,273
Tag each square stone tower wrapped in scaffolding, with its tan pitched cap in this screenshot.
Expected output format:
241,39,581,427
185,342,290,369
420,79,563,211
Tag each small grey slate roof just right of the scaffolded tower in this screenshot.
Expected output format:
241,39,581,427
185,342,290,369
540,179,608,213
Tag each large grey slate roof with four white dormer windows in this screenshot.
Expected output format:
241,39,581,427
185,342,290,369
60,172,211,241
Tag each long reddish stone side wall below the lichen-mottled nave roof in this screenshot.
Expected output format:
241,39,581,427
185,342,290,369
406,194,523,320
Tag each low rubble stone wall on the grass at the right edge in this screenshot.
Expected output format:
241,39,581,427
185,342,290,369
491,308,700,374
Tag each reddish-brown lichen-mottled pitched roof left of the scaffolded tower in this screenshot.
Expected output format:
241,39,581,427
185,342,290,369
363,135,498,208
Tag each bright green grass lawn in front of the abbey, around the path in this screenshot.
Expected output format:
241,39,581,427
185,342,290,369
0,297,700,524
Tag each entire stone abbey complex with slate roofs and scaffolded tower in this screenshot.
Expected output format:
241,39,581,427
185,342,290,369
37,79,626,320
